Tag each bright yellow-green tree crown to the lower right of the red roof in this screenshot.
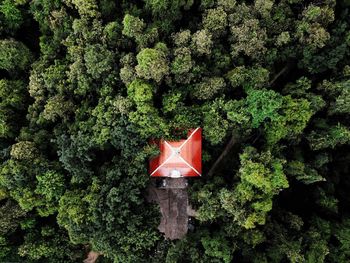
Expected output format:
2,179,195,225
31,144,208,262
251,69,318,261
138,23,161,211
226,147,289,229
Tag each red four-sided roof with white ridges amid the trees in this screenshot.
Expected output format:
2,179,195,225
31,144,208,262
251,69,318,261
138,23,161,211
150,128,202,178
